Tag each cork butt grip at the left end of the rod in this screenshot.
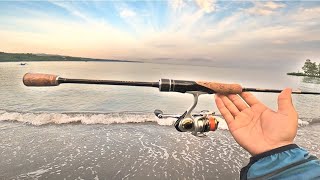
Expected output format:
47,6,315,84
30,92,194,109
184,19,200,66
23,73,60,86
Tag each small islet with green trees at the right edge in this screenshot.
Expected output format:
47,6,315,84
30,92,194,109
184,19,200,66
287,59,320,77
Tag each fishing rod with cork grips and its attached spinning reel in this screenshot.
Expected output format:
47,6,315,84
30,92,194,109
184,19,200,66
23,73,320,136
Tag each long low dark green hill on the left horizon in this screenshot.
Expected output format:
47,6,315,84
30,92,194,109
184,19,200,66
0,52,139,62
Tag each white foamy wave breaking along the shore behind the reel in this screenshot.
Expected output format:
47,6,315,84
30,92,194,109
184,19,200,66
0,110,311,130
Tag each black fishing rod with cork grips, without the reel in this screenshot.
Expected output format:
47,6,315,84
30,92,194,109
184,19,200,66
23,73,320,95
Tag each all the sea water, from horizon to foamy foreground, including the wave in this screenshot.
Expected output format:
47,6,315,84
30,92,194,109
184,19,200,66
0,62,320,179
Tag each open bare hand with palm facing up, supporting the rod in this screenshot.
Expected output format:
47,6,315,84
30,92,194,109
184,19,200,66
215,89,298,156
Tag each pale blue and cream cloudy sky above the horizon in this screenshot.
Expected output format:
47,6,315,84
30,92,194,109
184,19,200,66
0,0,320,66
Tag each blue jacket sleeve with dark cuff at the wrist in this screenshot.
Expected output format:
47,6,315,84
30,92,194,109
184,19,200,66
240,144,320,180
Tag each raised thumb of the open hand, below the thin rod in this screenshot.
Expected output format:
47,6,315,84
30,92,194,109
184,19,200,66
278,88,294,114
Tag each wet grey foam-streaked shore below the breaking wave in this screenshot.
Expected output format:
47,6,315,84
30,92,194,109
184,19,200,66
0,122,320,179
